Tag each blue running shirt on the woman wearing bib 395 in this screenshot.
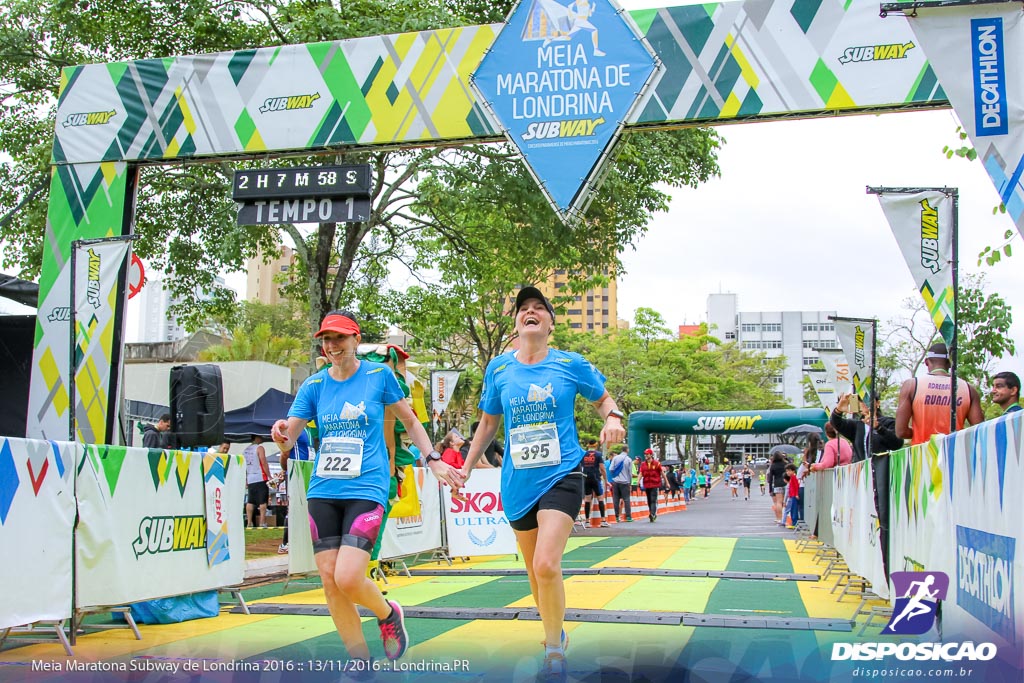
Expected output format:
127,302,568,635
479,348,604,521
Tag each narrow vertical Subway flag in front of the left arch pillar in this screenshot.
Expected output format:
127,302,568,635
72,240,129,443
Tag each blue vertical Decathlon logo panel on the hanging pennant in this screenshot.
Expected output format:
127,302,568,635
971,16,1008,137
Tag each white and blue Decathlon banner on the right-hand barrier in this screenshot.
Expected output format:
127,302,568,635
930,411,1024,655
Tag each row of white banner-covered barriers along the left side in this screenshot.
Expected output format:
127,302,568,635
0,438,245,629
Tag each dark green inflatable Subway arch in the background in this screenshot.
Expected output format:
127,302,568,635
626,408,828,457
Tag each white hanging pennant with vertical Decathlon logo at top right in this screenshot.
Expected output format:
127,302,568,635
907,2,1024,240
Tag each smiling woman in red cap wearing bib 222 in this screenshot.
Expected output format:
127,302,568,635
270,310,462,674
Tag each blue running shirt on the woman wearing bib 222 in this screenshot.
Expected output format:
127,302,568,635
288,360,404,505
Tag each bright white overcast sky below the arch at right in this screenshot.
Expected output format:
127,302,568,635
618,111,1024,375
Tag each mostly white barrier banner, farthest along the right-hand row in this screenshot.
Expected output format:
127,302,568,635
833,460,889,598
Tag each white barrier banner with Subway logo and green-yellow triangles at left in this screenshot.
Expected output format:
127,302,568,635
75,445,245,607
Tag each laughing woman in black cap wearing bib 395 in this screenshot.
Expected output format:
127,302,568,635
462,287,626,681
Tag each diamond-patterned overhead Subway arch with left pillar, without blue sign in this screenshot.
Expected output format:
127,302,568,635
27,0,1016,443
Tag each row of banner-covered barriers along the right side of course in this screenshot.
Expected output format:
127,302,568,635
805,412,1024,668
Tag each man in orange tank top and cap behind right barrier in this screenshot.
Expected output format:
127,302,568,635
896,342,985,444
